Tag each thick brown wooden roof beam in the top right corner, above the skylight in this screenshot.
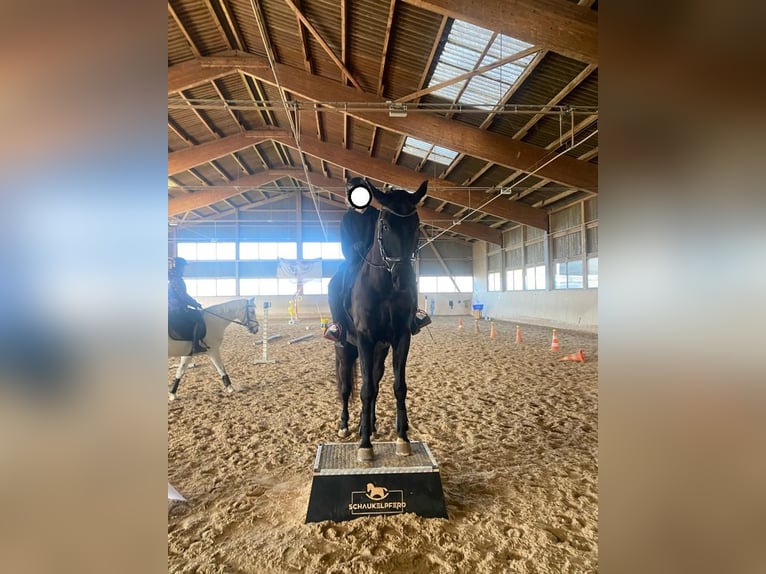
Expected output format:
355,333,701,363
404,0,598,64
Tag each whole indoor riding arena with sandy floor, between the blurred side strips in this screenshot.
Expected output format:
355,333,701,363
167,0,599,574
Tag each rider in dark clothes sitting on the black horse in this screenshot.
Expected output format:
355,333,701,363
323,177,431,345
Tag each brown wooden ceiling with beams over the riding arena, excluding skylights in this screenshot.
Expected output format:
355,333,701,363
168,0,598,244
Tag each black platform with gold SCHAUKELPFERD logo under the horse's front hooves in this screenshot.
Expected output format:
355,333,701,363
306,441,449,522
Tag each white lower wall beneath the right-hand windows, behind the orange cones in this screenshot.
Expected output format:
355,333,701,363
473,242,598,332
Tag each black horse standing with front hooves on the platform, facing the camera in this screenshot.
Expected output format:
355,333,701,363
335,181,428,462
